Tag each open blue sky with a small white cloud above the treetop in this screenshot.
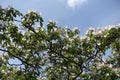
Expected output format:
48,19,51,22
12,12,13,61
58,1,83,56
0,0,120,34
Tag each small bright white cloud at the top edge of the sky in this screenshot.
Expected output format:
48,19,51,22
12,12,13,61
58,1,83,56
67,0,87,9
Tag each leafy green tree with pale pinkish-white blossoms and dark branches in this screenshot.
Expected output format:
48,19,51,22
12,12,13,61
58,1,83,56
0,7,120,80
